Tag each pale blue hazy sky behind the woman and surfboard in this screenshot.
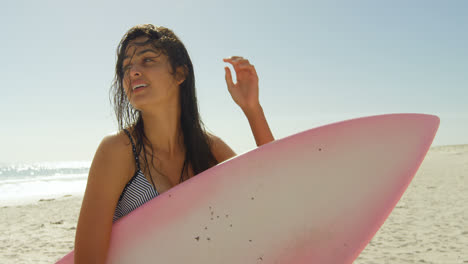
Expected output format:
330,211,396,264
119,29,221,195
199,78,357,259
0,0,468,163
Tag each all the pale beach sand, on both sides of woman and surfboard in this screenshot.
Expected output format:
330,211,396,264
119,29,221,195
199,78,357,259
0,145,468,264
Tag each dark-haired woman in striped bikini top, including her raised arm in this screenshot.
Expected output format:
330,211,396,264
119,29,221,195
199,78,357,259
75,24,274,263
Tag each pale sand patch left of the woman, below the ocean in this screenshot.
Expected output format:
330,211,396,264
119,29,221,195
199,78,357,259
0,196,83,264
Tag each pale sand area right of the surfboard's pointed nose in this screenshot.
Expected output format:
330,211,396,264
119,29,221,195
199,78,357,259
354,145,468,264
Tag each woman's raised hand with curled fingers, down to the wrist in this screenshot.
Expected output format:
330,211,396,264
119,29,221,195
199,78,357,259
223,56,260,112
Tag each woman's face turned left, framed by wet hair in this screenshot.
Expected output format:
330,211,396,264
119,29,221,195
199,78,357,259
122,37,183,111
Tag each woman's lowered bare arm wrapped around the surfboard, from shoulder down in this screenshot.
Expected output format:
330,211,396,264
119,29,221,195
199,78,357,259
75,136,129,264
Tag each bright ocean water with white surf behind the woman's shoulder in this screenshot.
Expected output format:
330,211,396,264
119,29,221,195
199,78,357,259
0,161,91,206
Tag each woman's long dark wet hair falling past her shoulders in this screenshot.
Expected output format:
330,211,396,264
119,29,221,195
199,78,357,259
110,24,218,185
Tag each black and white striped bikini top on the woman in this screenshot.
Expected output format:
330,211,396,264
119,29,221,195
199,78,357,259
113,170,159,222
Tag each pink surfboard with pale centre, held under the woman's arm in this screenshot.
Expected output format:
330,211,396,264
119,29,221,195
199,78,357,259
58,114,439,264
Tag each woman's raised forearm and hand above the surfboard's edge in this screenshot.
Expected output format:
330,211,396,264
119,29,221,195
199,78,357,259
224,56,275,146
